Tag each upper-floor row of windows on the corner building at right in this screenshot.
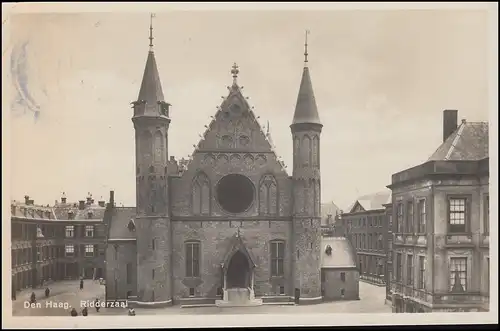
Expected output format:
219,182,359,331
396,195,490,234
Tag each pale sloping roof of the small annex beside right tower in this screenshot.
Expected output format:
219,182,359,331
321,237,356,268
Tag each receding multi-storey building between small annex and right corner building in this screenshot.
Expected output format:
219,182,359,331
340,191,390,286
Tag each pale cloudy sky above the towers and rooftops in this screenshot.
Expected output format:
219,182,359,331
3,10,489,208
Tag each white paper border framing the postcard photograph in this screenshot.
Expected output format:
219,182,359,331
2,2,498,328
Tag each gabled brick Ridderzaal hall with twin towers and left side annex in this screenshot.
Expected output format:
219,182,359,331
106,27,322,307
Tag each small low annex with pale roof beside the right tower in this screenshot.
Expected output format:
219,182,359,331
321,237,359,301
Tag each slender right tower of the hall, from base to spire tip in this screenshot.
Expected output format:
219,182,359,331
290,31,323,303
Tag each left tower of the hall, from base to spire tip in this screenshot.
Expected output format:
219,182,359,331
132,15,171,306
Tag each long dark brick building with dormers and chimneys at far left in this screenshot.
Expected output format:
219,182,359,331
11,192,106,294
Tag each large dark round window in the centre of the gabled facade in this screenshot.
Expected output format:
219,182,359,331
216,174,254,214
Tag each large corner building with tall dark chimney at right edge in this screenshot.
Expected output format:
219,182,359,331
388,110,490,312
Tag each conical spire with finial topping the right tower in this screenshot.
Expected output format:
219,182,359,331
292,32,321,124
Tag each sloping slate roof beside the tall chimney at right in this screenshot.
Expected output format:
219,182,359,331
428,120,489,161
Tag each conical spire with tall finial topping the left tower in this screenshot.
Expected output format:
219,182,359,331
137,15,164,105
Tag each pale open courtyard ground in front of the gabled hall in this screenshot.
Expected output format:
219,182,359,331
9,280,391,316
